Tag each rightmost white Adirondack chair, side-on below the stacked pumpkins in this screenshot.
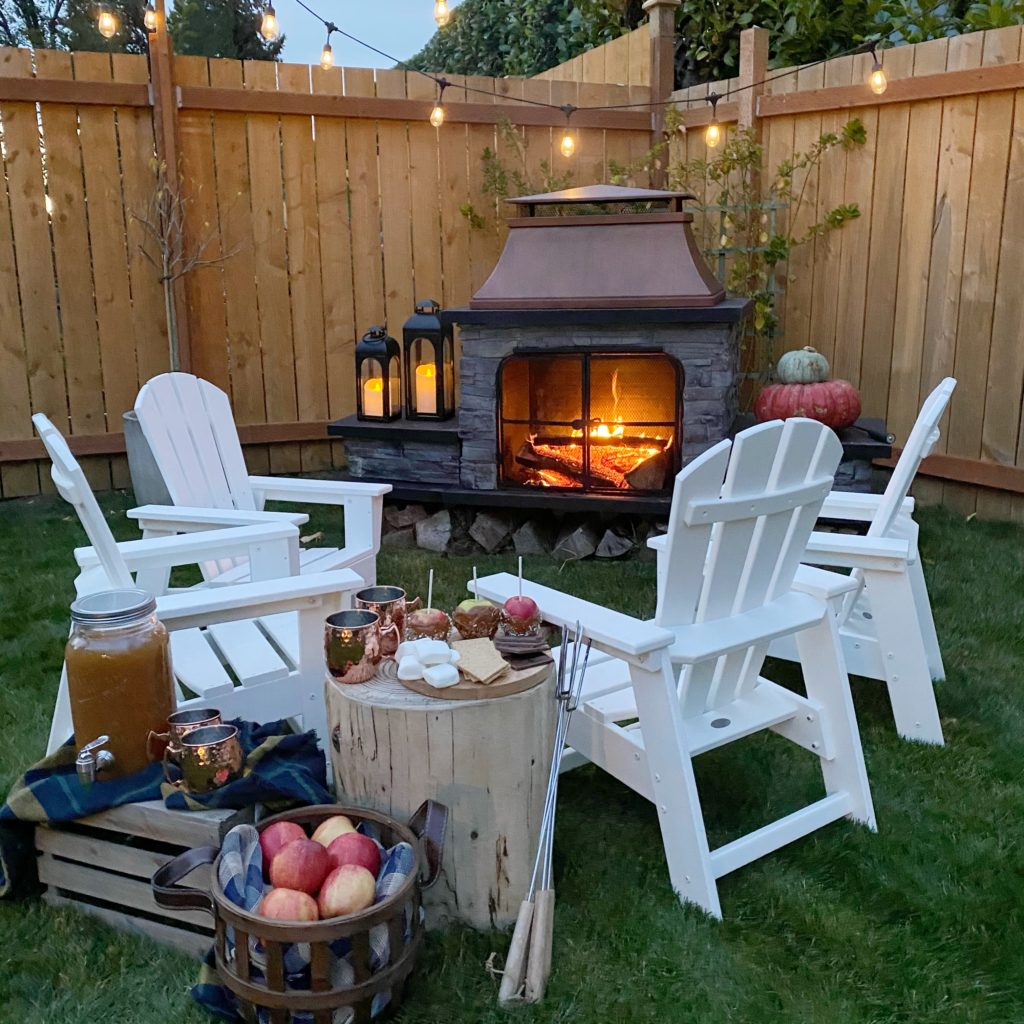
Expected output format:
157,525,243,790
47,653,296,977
769,377,956,743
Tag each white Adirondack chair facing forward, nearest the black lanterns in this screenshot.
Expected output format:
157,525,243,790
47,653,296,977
129,373,391,586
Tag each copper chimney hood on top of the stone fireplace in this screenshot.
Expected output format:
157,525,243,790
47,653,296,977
469,185,725,309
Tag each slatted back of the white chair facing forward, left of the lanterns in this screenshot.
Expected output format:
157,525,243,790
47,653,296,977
135,373,256,510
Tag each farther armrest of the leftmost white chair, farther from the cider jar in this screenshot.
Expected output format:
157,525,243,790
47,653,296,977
75,522,299,575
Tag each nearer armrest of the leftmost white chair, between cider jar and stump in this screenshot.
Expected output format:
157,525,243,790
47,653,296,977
157,569,364,630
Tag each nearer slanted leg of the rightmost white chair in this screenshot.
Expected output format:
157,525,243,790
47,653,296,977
865,571,943,744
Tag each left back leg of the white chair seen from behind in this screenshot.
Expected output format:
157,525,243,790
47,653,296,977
630,653,722,919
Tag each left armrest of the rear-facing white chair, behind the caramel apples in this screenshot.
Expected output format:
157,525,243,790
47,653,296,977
467,572,675,662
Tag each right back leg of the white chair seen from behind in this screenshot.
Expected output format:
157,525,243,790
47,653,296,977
797,614,876,831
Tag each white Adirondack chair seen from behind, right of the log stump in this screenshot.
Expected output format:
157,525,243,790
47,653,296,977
479,420,874,918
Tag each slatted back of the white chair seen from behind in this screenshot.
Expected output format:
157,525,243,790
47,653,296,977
655,419,843,716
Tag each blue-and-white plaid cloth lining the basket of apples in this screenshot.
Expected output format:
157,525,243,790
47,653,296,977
193,821,417,1024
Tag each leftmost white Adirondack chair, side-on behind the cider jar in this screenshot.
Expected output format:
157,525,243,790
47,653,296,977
33,414,362,761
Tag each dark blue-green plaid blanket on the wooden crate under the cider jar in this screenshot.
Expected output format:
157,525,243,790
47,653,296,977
0,719,332,898
